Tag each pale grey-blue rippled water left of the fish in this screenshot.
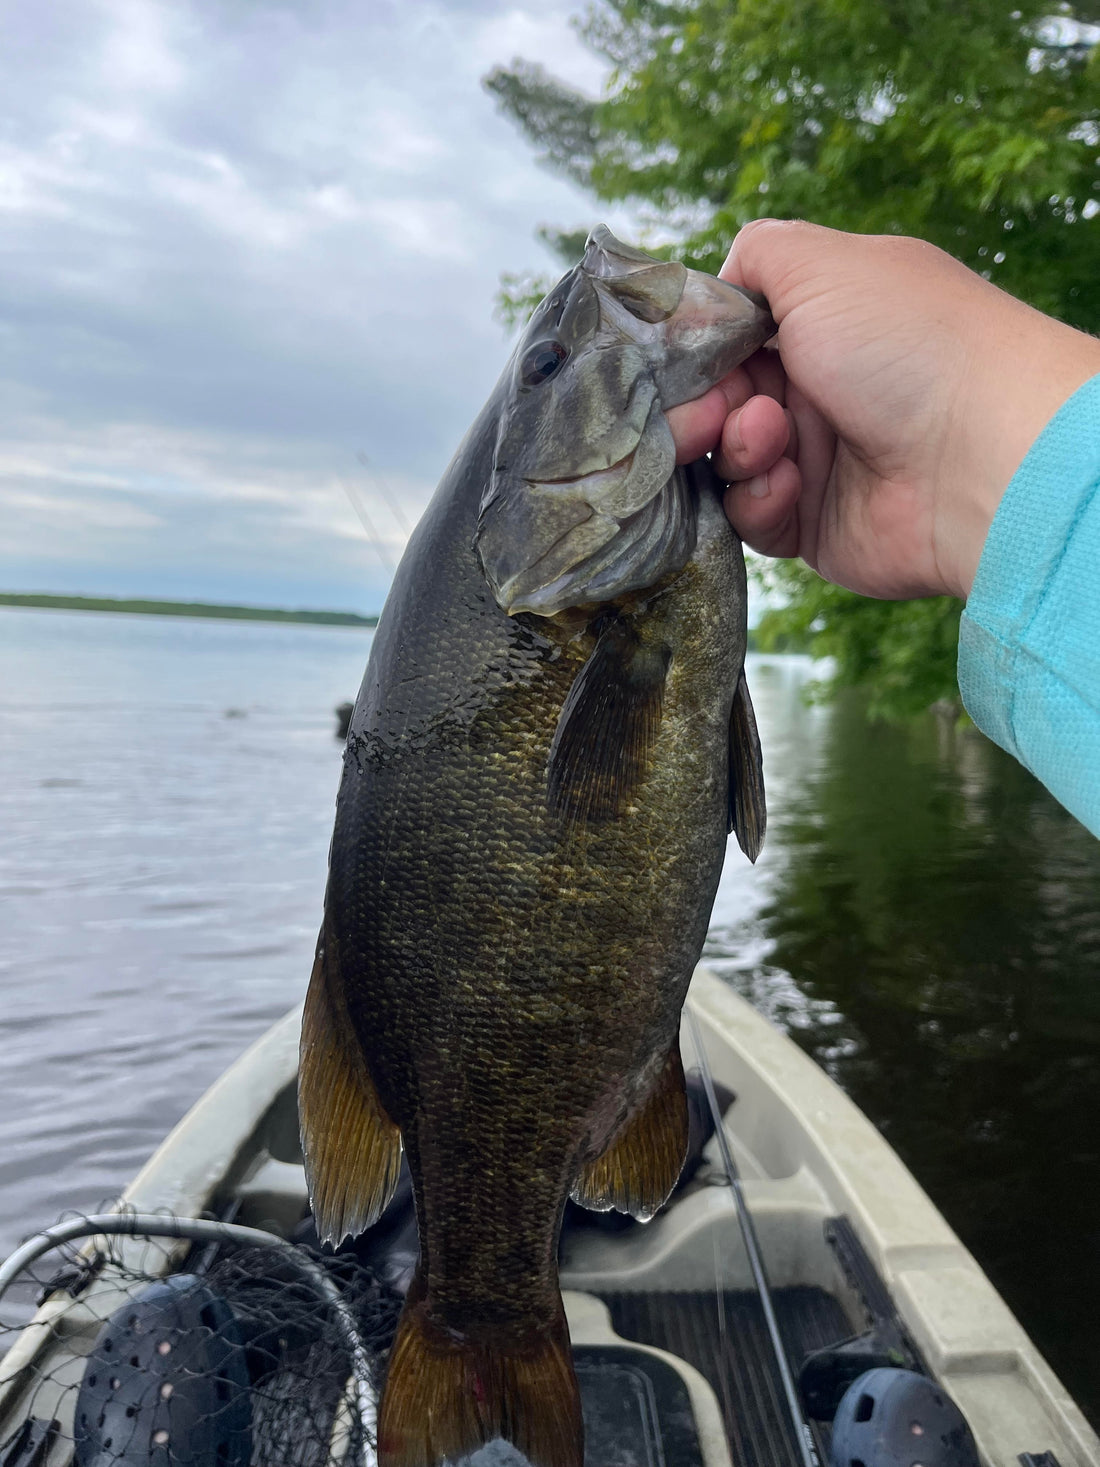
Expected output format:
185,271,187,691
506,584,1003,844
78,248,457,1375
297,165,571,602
0,609,370,1273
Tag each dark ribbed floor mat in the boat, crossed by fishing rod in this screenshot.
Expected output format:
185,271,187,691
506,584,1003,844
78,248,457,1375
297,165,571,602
600,1288,854,1467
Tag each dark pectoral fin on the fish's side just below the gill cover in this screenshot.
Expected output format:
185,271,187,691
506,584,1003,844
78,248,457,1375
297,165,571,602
547,616,670,823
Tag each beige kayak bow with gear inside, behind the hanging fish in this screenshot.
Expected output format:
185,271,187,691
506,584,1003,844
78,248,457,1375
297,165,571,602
0,967,1100,1467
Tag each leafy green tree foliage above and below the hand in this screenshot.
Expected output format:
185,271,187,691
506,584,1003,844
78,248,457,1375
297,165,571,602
485,0,1100,716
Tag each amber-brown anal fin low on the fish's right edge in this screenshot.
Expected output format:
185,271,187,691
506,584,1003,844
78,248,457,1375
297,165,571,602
573,1043,688,1222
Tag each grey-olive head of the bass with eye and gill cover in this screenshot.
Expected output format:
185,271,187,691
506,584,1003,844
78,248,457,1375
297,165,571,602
475,224,776,616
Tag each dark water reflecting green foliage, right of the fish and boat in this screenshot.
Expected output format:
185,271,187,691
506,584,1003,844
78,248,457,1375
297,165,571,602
711,663,1100,1419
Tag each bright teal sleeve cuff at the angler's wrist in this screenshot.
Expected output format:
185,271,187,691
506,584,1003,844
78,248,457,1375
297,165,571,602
959,376,1100,835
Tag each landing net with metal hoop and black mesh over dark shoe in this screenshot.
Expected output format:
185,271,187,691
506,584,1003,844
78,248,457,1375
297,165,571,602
0,1214,402,1467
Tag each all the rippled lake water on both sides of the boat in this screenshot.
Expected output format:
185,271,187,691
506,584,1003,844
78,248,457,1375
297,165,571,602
0,609,1100,1419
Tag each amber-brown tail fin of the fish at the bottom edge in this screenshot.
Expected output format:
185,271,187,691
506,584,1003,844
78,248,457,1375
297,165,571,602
378,1285,584,1467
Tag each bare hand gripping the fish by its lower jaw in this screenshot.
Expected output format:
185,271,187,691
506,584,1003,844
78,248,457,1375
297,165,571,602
669,220,1100,599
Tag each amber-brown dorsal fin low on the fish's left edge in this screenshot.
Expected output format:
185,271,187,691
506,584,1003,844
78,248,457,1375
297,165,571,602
298,937,400,1245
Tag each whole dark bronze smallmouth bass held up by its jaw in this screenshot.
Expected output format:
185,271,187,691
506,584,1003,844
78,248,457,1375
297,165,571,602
299,226,776,1467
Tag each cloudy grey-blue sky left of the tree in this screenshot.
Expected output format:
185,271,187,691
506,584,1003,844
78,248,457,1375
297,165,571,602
0,0,636,612
